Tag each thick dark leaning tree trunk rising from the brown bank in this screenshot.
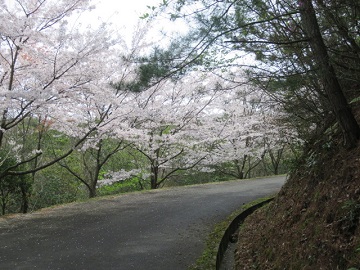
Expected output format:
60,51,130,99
299,0,360,148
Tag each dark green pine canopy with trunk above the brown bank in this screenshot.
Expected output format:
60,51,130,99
153,0,360,148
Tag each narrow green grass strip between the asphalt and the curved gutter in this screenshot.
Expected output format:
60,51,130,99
188,195,274,270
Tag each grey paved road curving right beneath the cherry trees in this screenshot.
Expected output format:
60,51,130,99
0,177,285,270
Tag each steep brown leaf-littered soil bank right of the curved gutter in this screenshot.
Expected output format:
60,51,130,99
235,130,360,270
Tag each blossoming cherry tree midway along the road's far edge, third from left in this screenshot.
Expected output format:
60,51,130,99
102,72,228,189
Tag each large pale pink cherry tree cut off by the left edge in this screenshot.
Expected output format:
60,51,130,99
0,0,129,212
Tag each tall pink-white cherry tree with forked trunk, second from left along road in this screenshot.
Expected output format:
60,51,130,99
50,17,159,197
